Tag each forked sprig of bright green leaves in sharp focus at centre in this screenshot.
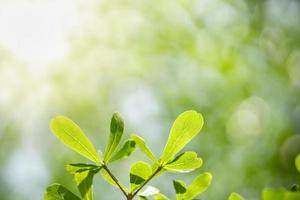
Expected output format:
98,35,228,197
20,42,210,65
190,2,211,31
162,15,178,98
44,110,212,200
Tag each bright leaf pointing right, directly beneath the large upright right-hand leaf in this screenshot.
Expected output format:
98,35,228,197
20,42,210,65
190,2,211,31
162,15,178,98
164,151,202,172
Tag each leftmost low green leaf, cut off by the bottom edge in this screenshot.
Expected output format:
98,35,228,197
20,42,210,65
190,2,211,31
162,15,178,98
44,183,80,200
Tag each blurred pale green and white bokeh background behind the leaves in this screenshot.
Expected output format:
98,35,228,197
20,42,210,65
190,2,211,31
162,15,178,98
0,0,300,200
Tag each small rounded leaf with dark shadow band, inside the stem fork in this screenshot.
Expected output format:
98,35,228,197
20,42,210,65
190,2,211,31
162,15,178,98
130,161,152,192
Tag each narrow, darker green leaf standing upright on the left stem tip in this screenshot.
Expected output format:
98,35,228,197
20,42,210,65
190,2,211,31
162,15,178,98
104,113,124,162
